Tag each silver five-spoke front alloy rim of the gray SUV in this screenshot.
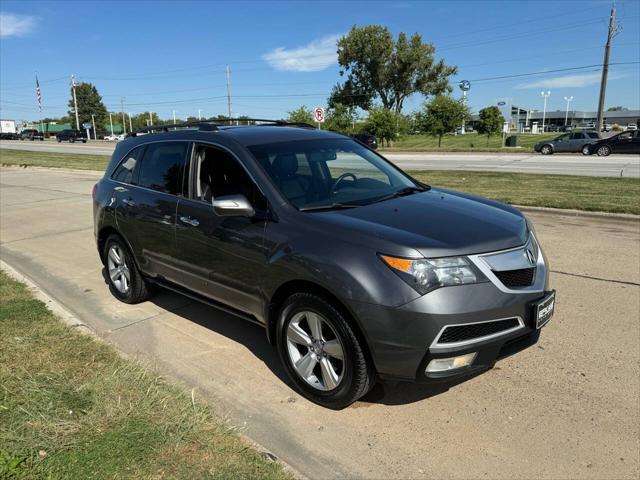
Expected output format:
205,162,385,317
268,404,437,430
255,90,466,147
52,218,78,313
287,310,345,391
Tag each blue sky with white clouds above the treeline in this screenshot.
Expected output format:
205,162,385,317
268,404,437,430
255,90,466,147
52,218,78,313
0,0,640,120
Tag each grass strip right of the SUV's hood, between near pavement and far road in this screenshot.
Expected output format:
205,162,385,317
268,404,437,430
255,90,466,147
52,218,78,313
409,170,640,215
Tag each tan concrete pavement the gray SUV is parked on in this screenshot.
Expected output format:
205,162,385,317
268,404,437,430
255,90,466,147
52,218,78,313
0,168,640,479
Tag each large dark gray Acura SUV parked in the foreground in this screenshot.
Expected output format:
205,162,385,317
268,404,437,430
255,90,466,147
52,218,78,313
93,122,555,408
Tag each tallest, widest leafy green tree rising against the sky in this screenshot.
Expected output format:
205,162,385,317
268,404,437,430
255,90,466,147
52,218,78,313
329,25,457,113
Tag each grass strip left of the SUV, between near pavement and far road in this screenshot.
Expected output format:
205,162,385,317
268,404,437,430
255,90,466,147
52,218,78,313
0,148,110,170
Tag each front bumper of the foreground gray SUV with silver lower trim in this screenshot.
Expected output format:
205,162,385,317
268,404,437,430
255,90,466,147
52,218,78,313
350,236,549,382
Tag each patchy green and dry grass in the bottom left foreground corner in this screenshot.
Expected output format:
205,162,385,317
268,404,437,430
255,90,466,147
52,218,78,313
0,272,290,479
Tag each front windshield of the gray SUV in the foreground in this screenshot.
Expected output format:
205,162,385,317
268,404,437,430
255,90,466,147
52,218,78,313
249,139,419,210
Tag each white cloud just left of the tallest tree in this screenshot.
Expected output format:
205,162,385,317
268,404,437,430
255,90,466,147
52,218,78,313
262,35,341,72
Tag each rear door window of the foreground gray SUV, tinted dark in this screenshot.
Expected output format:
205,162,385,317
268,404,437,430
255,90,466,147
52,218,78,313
138,142,189,195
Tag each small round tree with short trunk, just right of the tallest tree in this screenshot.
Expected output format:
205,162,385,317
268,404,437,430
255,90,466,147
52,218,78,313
418,95,469,148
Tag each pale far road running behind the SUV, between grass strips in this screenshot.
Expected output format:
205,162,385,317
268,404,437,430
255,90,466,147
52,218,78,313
0,141,640,177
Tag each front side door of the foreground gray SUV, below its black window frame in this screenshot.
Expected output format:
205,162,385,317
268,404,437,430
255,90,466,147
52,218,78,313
176,145,268,315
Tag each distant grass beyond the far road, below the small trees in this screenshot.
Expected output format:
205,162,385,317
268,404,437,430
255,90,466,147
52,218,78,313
381,133,560,152
